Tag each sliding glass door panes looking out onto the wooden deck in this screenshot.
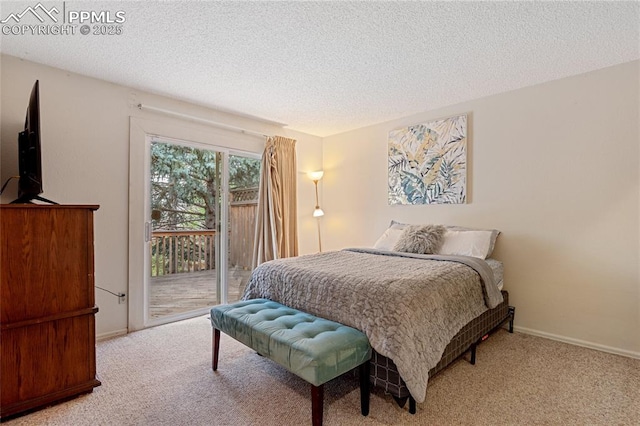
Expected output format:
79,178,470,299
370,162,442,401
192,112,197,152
145,138,260,325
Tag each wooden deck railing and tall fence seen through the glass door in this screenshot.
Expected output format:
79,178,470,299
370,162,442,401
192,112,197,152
151,188,258,277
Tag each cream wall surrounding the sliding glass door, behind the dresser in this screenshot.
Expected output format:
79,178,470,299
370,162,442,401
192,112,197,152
0,55,322,336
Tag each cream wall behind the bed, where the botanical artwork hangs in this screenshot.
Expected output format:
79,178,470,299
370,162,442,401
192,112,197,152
323,61,640,357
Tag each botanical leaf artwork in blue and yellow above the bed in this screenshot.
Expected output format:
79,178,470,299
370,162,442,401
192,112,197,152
388,114,467,204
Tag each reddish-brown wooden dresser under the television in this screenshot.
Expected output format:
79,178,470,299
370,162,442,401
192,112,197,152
0,204,100,418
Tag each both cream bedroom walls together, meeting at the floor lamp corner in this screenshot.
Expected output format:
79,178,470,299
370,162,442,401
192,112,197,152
0,55,640,357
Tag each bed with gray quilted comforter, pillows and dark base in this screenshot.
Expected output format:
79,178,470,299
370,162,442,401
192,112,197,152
243,222,513,413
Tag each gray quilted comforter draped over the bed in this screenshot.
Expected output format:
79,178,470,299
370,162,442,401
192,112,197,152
243,249,502,402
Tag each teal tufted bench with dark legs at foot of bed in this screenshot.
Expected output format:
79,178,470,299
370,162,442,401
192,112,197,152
211,299,371,426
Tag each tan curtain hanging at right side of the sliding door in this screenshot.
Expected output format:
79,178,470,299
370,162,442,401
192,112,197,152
253,136,298,268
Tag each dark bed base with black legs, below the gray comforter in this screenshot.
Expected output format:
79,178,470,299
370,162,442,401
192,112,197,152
370,290,515,414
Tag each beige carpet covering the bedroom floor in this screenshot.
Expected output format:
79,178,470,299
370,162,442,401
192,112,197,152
6,317,640,426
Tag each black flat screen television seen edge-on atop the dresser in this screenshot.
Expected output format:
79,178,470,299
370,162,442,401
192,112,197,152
12,80,57,204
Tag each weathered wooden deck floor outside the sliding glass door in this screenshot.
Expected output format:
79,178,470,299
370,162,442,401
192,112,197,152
149,269,251,318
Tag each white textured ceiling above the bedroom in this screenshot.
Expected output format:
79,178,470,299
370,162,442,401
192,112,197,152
0,0,640,136
